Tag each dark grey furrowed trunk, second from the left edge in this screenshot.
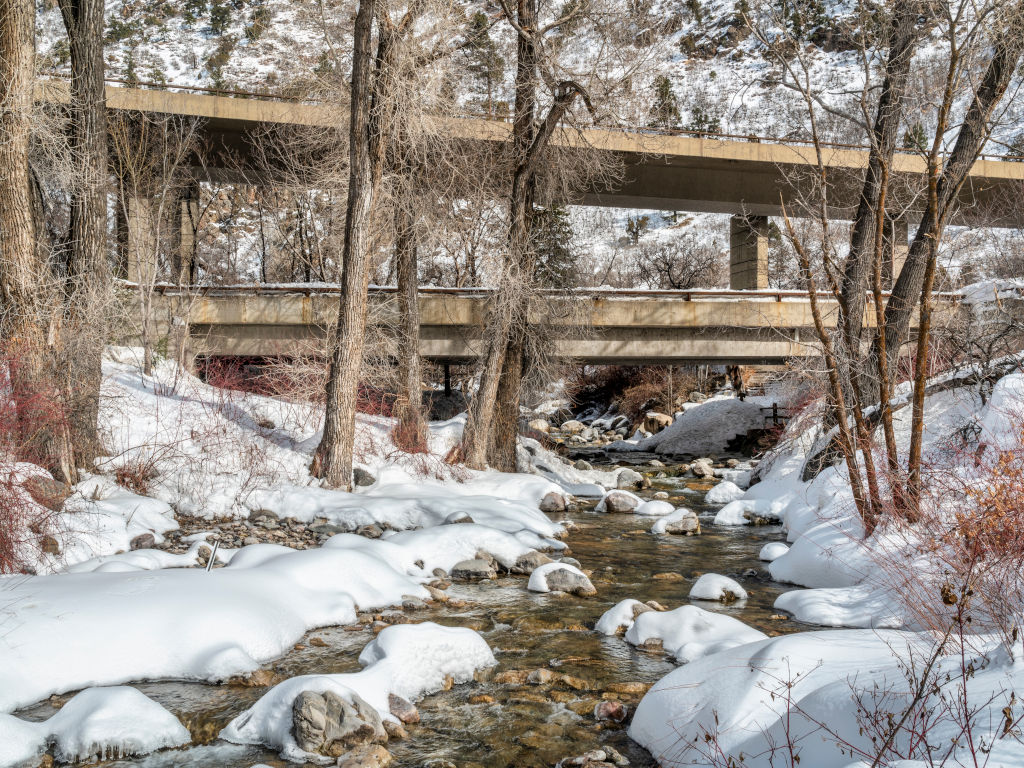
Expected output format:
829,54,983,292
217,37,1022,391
59,0,110,466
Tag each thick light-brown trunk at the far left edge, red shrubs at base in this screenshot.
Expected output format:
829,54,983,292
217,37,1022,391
0,0,78,482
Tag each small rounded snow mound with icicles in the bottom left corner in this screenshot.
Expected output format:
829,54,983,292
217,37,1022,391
0,687,191,766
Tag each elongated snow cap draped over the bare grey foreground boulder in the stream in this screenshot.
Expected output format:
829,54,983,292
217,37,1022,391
220,622,497,762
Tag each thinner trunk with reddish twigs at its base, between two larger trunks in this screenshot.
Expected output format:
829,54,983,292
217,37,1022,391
395,204,427,451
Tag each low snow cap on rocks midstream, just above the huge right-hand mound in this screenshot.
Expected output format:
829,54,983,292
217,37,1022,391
626,605,767,663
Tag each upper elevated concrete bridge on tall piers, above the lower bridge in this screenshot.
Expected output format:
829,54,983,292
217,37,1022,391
45,81,1024,290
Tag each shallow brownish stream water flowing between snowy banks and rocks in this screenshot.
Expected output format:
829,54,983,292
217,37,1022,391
20,457,799,768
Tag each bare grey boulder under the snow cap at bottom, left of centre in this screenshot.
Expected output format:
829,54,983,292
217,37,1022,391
292,690,387,758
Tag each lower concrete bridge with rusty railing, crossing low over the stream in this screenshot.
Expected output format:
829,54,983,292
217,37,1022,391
144,286,950,365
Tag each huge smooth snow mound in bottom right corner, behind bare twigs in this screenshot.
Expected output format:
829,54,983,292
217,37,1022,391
630,630,1024,768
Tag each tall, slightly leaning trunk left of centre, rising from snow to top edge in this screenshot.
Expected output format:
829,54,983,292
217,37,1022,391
310,0,379,489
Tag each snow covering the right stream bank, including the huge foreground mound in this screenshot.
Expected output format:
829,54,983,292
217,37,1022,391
626,358,1024,768
